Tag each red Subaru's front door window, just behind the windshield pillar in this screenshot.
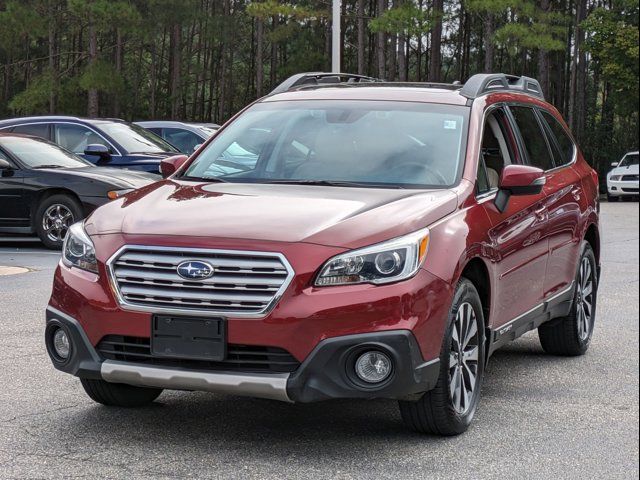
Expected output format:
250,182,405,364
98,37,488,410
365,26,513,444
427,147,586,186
476,109,513,195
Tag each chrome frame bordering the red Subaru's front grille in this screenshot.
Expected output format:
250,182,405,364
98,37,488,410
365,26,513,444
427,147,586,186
106,245,295,318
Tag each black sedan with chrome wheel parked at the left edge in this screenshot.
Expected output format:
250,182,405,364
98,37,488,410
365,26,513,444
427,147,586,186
0,133,157,248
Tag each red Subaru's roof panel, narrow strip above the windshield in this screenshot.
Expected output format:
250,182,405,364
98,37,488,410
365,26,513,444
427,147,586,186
261,84,468,105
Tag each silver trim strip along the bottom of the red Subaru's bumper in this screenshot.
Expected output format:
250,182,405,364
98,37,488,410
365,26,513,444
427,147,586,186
100,360,292,402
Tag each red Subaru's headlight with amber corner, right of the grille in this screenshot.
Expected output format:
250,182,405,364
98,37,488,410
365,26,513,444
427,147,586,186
315,229,429,287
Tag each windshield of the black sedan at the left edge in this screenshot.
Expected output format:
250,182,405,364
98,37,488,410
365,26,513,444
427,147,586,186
0,137,93,168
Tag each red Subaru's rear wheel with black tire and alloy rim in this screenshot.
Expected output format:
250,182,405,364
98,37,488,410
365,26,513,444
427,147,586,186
538,242,598,357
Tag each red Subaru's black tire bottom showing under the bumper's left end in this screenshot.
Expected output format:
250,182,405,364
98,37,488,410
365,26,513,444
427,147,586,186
80,378,162,408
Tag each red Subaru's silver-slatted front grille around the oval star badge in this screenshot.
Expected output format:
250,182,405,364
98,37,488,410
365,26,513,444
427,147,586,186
109,246,293,316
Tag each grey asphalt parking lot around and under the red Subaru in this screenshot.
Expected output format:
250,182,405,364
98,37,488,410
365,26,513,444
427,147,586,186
0,203,639,479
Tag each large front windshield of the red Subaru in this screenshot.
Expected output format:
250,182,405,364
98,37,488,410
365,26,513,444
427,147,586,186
184,101,469,188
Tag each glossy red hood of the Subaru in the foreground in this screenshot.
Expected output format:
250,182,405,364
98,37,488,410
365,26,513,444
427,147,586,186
85,180,458,248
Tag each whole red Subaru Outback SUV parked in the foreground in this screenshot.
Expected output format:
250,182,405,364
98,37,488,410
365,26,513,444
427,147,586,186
46,74,600,435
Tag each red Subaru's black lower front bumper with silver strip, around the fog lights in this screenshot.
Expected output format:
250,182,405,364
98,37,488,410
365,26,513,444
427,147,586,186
46,307,440,403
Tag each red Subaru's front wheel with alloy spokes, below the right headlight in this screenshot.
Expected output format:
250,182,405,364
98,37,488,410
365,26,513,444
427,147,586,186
399,279,485,436
